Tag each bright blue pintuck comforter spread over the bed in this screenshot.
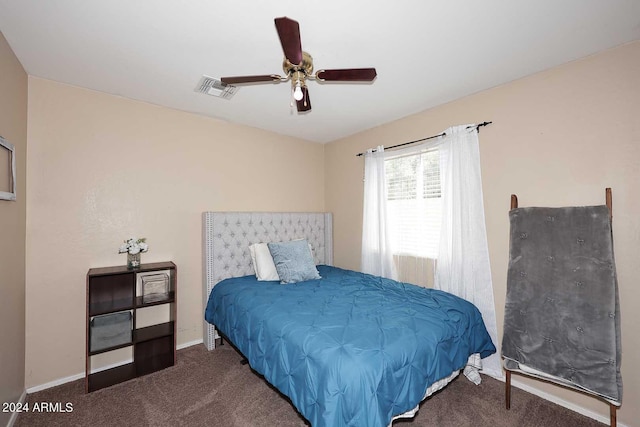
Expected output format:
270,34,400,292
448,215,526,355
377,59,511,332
205,266,495,427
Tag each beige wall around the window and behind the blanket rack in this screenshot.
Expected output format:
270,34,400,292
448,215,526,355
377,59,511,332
325,42,640,426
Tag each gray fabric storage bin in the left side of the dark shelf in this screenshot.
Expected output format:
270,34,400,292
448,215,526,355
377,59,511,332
89,311,133,351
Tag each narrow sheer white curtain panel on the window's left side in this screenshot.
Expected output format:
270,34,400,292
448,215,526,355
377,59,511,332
360,146,397,279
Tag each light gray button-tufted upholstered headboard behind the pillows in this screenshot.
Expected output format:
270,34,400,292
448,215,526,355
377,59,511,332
202,212,333,350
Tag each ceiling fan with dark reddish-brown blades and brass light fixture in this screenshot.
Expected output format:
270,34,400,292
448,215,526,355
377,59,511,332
220,16,377,113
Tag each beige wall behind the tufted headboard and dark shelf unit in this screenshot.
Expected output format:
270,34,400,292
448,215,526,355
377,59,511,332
26,77,324,387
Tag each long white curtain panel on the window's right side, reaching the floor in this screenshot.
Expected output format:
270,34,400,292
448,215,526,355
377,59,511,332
435,125,502,378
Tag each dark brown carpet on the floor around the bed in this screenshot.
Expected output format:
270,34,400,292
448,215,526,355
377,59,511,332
16,345,604,427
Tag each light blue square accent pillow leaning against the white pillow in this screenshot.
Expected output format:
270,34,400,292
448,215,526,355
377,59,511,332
268,240,321,284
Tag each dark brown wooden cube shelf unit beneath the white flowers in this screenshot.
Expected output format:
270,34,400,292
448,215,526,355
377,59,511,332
85,261,178,393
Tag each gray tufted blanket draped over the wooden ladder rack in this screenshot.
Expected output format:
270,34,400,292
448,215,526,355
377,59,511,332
502,206,622,406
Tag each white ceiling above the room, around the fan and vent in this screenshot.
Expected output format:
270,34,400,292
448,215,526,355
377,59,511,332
0,0,640,143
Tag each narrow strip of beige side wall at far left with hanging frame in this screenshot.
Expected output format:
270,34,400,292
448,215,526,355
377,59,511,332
0,33,28,425
